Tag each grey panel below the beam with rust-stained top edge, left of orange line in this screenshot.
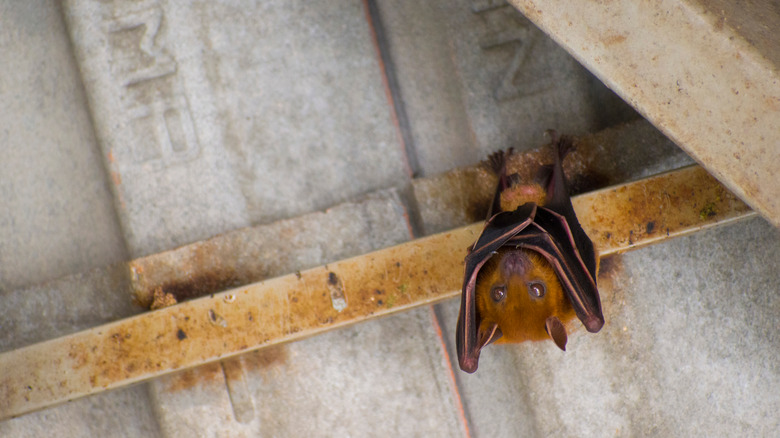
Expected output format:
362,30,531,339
151,308,464,437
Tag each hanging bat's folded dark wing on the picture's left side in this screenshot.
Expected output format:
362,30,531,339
456,203,536,373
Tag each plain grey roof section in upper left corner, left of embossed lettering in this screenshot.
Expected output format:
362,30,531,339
0,1,127,292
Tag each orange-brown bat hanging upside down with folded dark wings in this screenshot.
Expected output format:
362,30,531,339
456,133,604,373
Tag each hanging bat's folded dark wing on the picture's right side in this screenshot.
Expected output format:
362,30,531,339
507,213,604,333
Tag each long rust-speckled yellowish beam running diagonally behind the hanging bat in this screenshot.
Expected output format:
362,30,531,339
0,166,753,419
